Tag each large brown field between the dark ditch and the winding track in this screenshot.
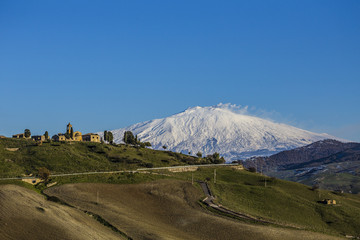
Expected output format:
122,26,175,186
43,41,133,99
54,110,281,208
45,180,337,240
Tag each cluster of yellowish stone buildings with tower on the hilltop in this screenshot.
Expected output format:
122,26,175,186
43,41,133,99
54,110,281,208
12,123,101,142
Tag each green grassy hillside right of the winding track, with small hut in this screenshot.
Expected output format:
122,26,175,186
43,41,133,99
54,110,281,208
165,167,360,236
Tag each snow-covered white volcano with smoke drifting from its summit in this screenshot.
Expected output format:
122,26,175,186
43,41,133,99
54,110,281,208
100,104,335,161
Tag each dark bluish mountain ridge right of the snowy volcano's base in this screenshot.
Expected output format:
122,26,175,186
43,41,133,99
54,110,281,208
243,139,360,193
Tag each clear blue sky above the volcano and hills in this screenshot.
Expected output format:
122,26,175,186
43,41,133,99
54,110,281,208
0,0,360,141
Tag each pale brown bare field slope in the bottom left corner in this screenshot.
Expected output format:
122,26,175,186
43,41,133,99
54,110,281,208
0,185,123,240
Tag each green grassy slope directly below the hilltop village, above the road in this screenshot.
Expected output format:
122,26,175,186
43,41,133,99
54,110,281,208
0,139,212,177
